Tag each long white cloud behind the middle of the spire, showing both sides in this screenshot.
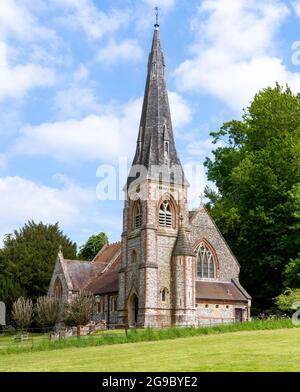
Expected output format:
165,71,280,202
13,92,191,162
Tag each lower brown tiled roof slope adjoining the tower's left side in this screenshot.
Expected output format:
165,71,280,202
85,256,121,294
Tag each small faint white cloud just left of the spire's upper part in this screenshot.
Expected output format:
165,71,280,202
97,39,143,64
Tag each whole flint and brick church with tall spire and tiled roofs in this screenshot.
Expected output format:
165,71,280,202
49,23,251,327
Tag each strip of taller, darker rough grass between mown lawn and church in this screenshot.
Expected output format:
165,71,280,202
0,319,295,356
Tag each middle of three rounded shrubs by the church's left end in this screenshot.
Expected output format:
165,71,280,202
35,296,62,328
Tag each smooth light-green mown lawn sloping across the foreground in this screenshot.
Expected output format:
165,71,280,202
0,328,300,372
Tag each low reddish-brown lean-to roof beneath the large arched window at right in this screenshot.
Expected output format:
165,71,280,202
196,281,248,301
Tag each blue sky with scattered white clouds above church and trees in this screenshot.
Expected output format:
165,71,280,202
0,0,300,250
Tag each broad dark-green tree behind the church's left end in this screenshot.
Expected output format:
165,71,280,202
0,221,77,305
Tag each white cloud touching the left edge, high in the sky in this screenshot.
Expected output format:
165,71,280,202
0,42,55,101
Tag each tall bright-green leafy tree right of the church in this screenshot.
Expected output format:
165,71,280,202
205,85,300,310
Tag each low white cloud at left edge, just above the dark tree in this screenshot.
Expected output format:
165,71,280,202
0,177,96,241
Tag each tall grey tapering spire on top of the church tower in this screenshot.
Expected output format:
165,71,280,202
128,20,186,188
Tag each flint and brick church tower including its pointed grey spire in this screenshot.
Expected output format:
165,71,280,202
118,22,195,327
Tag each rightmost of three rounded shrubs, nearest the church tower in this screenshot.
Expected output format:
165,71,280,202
64,291,96,326
